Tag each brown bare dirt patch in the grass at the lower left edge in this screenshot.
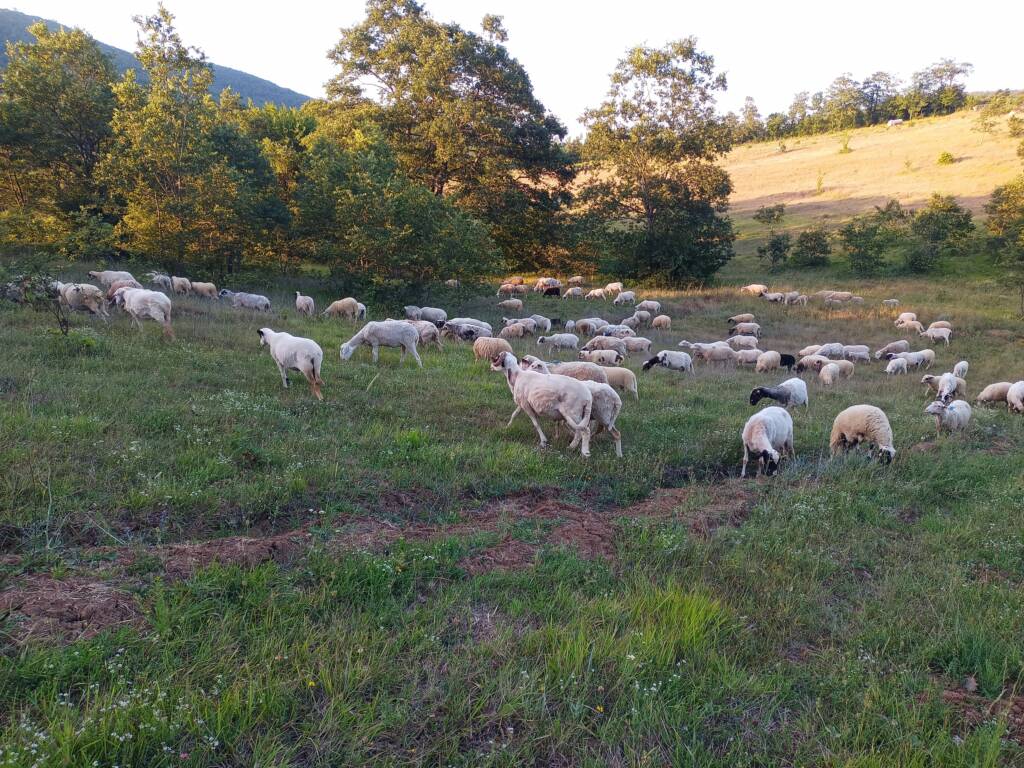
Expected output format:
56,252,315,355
0,574,142,641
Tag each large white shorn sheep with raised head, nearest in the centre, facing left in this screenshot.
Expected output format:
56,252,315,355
490,352,594,457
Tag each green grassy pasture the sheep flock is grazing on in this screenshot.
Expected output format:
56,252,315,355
0,268,1024,767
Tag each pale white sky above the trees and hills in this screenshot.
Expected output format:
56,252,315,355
14,0,1024,133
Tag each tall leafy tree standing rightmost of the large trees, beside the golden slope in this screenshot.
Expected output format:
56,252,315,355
580,38,734,285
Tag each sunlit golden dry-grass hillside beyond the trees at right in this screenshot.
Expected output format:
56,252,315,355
725,112,1021,241
